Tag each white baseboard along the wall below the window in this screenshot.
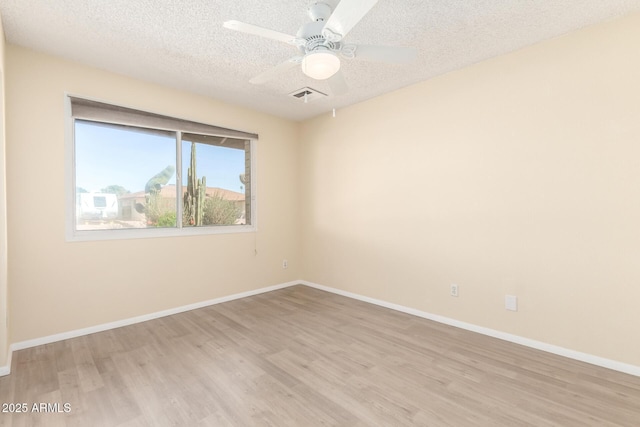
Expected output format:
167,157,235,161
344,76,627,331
0,281,300,376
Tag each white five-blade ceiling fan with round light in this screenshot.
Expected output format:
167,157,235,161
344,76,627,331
223,0,416,95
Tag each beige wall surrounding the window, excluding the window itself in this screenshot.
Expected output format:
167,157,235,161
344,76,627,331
6,45,301,342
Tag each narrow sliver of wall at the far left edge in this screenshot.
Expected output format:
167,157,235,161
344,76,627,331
0,14,9,368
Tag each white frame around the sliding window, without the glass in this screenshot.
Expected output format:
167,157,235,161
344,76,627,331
64,93,258,242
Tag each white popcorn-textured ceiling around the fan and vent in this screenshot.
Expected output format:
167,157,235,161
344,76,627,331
0,0,640,120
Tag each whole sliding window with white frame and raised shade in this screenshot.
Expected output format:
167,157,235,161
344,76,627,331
67,97,257,240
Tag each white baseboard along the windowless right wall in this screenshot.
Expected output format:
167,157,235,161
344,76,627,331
300,280,640,377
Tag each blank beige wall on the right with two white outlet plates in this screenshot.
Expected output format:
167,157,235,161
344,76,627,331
300,14,640,365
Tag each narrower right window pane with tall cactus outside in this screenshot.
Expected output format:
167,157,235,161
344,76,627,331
182,134,251,227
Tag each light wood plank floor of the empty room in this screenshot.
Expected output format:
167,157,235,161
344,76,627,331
0,286,640,427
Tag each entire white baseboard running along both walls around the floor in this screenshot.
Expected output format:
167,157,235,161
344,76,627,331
0,280,640,377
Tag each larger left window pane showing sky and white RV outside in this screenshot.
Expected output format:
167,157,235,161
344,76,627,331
74,120,177,230
